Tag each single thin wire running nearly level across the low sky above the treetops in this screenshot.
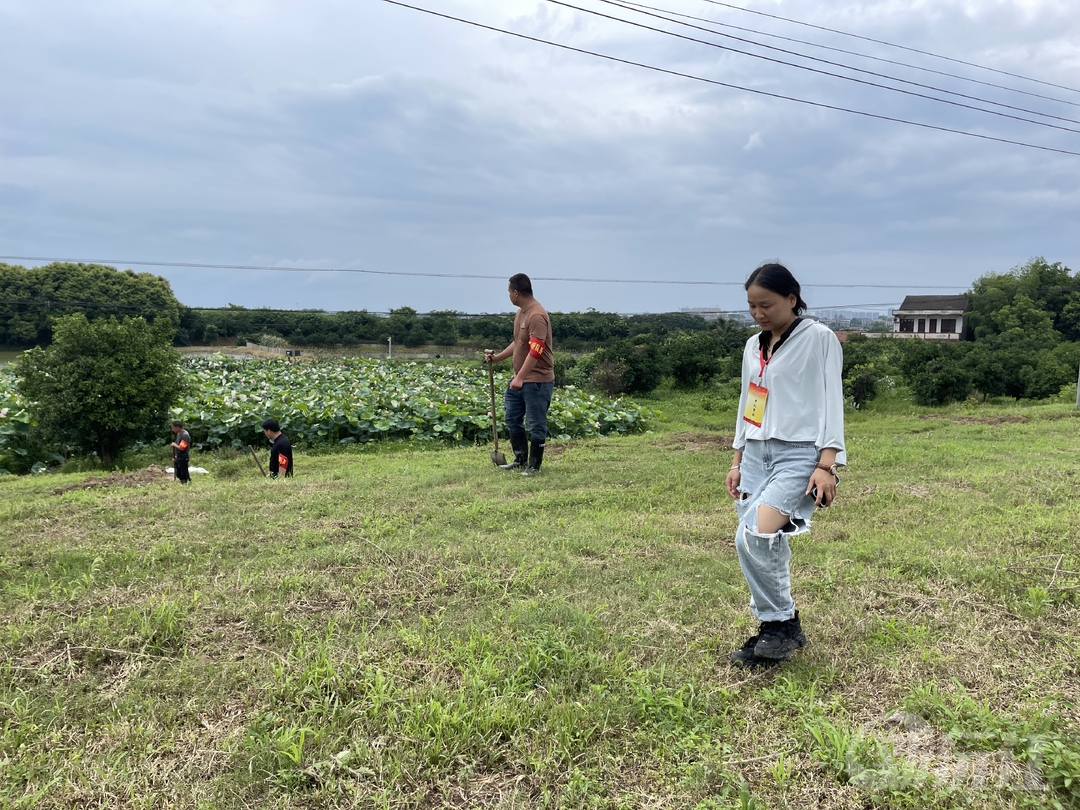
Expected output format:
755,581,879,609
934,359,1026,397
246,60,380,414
0,258,972,289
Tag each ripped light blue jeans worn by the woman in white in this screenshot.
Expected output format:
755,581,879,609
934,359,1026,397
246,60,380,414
735,438,820,622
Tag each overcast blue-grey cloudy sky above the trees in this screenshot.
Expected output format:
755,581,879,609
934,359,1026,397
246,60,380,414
0,0,1080,312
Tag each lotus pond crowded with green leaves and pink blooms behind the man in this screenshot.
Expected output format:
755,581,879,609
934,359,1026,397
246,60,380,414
0,355,657,468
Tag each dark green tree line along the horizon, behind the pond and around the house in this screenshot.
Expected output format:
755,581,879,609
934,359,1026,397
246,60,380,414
0,258,1080,405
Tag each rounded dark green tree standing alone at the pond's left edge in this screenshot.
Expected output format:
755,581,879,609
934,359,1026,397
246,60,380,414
17,313,184,464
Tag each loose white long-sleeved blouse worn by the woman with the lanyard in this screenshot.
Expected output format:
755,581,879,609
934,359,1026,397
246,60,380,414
734,321,848,464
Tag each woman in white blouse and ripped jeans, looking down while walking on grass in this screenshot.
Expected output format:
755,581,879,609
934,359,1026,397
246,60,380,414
725,264,847,666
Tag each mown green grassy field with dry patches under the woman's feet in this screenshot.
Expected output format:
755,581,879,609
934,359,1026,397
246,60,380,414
0,394,1080,810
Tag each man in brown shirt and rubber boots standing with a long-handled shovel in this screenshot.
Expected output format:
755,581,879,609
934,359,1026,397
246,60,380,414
484,273,555,475
